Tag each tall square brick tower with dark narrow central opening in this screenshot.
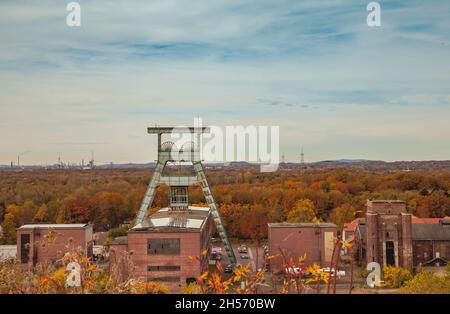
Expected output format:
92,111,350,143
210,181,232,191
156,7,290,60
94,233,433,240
366,200,413,268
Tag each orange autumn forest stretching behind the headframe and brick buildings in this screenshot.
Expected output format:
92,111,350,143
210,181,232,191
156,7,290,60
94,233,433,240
0,167,450,244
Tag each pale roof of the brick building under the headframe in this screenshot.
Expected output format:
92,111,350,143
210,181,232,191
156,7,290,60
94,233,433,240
130,206,210,232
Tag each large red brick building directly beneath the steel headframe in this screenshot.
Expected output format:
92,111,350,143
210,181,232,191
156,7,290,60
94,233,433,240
110,206,212,292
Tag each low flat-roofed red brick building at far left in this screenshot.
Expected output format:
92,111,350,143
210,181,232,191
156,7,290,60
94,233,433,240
17,224,93,266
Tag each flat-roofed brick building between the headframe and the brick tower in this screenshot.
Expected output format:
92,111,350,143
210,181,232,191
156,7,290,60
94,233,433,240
268,222,337,272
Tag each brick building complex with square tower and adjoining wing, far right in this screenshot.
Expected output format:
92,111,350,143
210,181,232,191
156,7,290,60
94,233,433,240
354,201,450,268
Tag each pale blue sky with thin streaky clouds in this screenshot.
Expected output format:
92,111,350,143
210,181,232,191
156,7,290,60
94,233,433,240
0,0,450,164
